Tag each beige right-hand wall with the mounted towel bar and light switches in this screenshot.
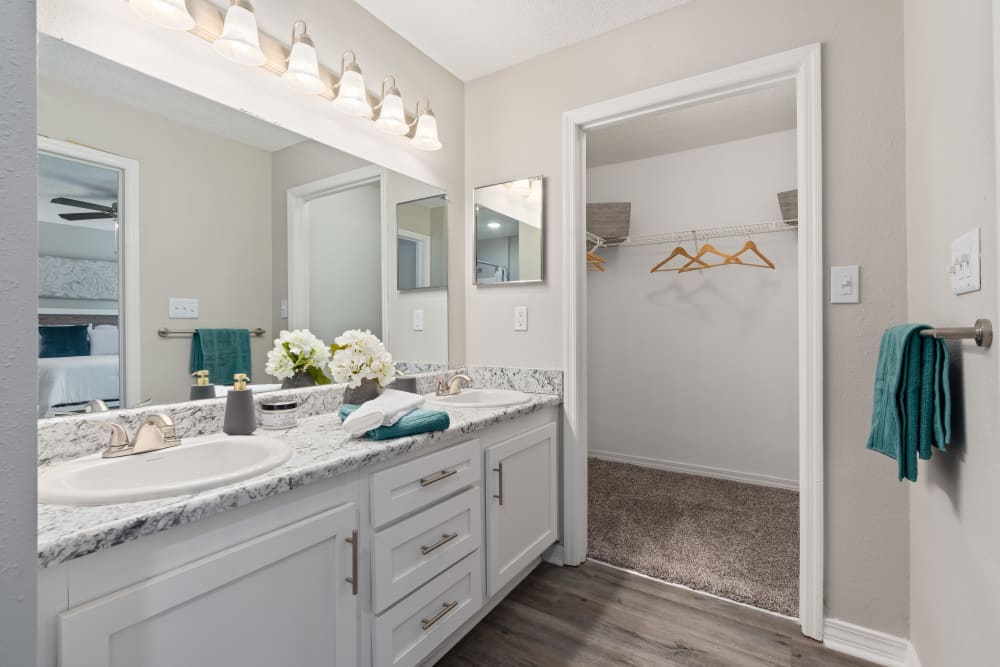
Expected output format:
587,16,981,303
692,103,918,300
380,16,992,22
904,0,1000,667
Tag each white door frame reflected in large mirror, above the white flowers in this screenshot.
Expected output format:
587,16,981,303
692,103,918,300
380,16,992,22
287,166,396,347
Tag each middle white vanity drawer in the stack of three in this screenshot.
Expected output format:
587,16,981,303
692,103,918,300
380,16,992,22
372,485,483,613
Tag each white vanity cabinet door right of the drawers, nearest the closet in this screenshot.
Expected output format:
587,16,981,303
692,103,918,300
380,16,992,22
486,424,559,597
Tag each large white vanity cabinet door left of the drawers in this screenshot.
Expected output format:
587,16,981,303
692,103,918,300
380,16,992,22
59,503,360,667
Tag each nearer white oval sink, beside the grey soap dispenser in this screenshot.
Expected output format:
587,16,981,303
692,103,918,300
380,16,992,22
38,435,292,505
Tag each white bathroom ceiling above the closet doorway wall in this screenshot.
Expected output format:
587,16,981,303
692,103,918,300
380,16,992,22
355,0,691,81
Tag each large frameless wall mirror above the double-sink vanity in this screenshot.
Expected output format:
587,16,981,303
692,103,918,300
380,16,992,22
38,35,448,417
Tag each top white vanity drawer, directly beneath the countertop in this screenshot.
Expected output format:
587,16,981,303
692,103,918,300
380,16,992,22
371,440,482,528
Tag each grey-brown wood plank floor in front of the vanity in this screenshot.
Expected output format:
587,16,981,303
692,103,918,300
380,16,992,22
437,561,870,667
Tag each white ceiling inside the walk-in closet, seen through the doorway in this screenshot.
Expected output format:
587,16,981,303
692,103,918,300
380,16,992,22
587,81,795,167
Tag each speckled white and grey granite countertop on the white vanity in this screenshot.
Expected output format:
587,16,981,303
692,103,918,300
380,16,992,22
38,394,562,568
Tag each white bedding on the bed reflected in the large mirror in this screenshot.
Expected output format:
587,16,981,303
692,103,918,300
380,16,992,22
38,354,119,417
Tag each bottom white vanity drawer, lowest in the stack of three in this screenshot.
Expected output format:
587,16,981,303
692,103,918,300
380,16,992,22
374,550,483,667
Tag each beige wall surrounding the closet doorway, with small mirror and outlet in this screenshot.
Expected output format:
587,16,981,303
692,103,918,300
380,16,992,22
465,0,912,635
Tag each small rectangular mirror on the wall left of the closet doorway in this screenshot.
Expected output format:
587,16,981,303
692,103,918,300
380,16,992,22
473,176,545,285
